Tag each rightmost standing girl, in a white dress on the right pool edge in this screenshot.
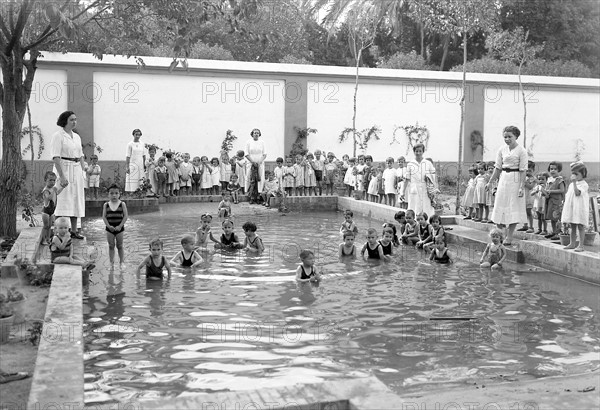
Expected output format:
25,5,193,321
560,162,590,252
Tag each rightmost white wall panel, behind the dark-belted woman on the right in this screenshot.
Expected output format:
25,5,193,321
484,87,600,166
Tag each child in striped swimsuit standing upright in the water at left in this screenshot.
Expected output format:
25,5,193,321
102,184,128,269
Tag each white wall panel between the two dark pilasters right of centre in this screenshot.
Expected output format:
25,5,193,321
307,81,460,161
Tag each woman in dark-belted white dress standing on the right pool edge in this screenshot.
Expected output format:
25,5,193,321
485,125,527,246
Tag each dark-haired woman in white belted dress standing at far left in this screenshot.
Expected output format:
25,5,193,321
50,111,85,239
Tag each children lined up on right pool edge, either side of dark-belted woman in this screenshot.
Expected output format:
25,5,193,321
461,161,589,252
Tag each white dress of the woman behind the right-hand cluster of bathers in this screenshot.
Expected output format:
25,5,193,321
404,159,435,216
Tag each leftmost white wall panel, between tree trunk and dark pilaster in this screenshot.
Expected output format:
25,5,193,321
0,69,68,160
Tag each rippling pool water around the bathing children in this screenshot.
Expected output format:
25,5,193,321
84,204,600,403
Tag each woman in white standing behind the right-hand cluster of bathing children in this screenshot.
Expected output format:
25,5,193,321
400,144,436,217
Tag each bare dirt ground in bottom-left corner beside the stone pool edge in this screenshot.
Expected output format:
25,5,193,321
0,278,50,408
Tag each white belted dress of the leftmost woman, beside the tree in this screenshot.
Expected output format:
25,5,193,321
50,130,85,217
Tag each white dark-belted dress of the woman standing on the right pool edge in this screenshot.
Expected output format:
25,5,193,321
490,145,527,225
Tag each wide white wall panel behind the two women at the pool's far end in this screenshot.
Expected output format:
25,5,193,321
94,72,285,160
